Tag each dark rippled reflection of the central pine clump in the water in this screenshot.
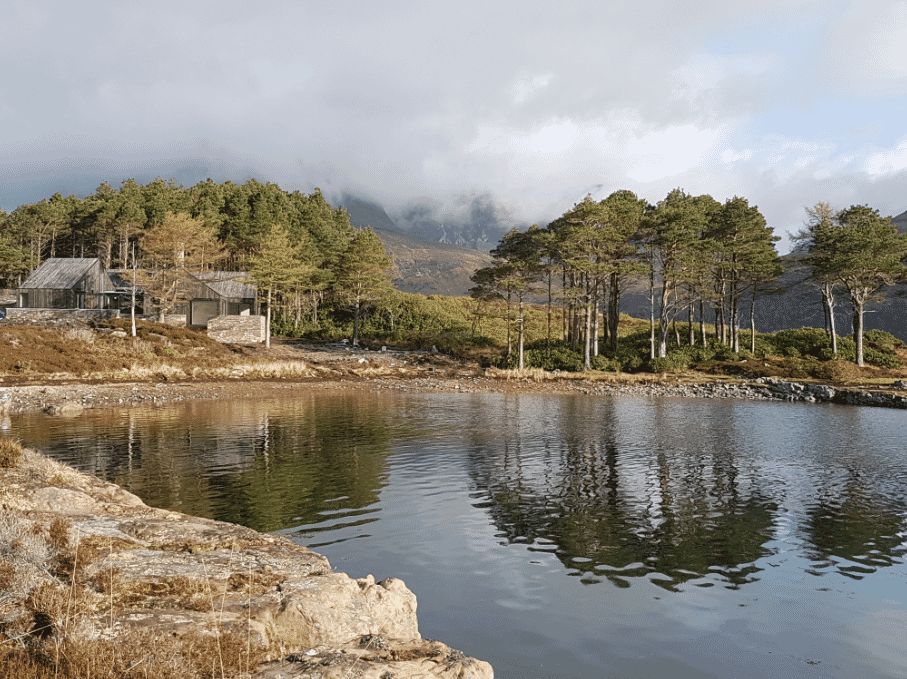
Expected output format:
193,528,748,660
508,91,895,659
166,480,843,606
469,399,777,588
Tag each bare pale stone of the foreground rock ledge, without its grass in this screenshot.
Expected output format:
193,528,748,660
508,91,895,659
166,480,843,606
0,451,494,679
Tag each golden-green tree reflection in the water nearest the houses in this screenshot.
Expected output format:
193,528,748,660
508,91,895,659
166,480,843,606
17,395,401,531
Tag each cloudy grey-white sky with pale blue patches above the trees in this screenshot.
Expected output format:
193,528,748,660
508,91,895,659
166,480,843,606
0,0,907,252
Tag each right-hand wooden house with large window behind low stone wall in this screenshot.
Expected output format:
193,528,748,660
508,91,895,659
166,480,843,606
185,271,259,328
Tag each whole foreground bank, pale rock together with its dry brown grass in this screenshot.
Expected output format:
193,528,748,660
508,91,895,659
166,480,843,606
0,439,493,679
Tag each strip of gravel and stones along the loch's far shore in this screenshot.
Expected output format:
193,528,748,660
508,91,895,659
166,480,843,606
0,344,907,416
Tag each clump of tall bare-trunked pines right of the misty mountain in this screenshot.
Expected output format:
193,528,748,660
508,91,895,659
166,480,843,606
472,189,781,370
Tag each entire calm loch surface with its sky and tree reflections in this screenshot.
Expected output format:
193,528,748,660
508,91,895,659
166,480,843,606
11,394,907,679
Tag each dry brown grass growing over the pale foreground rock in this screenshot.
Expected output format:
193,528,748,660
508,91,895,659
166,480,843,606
0,502,274,679
